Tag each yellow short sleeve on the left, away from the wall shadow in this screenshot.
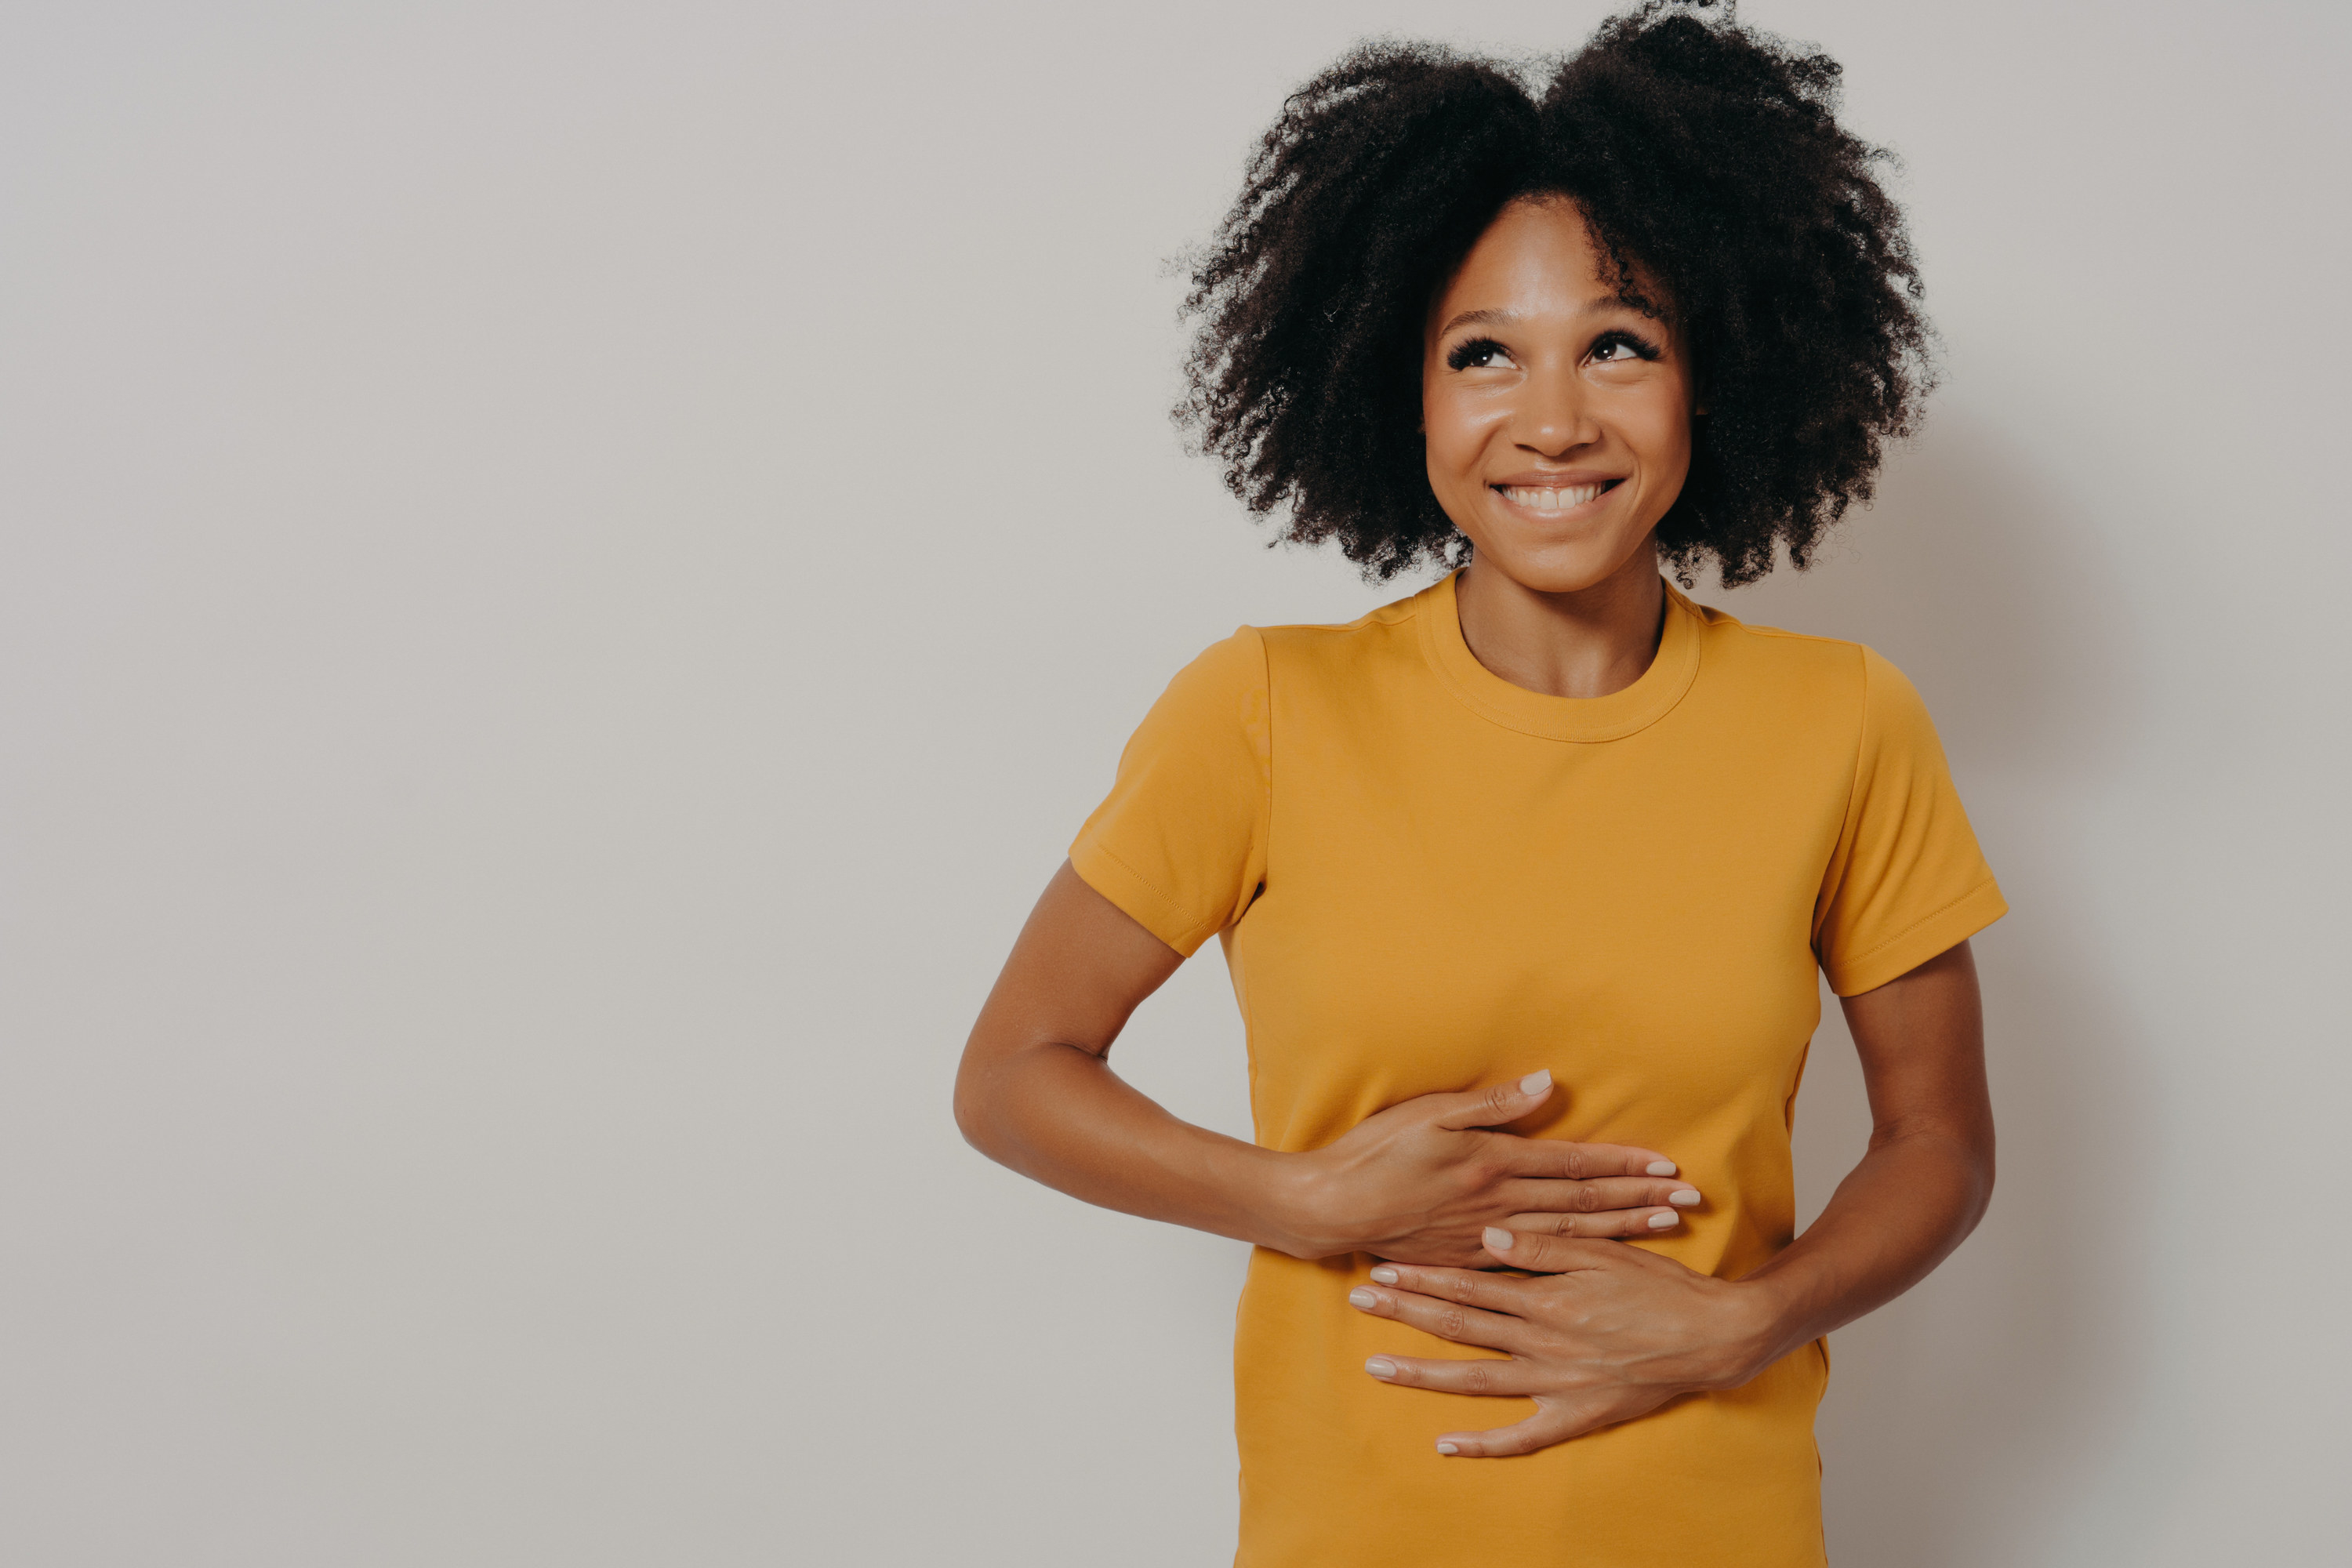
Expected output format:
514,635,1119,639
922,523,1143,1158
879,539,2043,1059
1070,626,1272,956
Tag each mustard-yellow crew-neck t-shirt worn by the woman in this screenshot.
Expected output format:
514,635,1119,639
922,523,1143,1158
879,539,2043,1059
1070,576,2009,1568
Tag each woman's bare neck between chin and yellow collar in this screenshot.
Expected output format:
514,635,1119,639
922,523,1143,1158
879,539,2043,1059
1454,548,1665,699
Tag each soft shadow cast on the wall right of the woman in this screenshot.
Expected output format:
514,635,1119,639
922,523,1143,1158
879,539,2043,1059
1696,416,2150,1568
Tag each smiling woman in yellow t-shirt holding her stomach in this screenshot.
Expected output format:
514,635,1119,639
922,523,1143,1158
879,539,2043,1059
957,5,2006,1568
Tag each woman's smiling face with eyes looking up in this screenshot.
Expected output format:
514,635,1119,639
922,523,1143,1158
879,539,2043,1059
1421,200,1693,593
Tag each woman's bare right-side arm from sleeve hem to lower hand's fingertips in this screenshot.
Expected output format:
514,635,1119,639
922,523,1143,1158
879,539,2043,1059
1350,942,1992,1457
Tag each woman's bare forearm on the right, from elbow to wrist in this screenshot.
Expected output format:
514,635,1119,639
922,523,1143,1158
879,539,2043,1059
1740,1128,1992,1368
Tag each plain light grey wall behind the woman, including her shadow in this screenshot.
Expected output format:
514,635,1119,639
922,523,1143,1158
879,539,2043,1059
0,0,2352,1568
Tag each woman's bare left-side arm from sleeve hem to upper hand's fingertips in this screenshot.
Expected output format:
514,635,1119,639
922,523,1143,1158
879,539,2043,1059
955,862,1698,1267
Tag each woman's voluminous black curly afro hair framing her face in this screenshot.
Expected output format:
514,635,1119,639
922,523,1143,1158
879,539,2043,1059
1176,0,1933,588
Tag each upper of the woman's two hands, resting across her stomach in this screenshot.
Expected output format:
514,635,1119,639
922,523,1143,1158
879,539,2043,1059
1289,1072,1698,1269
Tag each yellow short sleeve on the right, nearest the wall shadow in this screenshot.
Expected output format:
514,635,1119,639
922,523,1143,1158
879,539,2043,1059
1813,649,2009,996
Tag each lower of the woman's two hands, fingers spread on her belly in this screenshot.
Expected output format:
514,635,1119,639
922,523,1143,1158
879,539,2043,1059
1348,1229,1783,1460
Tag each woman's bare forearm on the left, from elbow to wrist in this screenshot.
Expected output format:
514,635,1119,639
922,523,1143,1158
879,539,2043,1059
955,1044,1331,1258
